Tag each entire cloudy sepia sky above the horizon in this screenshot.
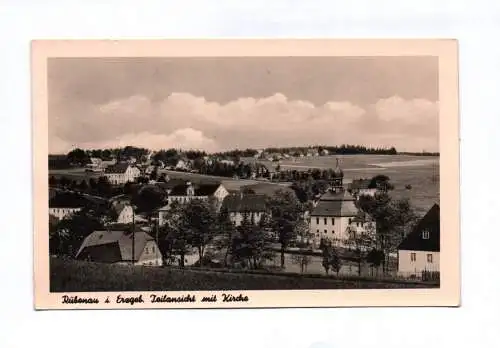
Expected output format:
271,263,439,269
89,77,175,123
48,57,439,153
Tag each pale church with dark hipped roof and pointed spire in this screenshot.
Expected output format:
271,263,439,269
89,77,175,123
309,159,375,247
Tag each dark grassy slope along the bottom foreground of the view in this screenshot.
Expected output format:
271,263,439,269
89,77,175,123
50,258,431,292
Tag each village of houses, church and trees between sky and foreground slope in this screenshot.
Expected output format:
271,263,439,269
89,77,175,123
49,147,440,288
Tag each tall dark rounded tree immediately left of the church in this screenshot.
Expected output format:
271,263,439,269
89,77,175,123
267,190,303,268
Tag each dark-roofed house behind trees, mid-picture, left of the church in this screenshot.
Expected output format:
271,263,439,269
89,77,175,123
221,193,267,226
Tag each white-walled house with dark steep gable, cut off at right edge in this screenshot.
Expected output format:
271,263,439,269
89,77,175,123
398,204,440,276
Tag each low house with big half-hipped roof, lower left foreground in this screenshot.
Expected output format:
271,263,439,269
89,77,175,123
76,229,163,266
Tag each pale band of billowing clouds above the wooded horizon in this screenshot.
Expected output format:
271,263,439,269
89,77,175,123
49,93,438,152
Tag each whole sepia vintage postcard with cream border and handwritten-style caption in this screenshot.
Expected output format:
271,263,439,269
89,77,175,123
32,39,460,309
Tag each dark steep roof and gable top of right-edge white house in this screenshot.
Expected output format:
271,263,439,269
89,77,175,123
398,204,440,251
